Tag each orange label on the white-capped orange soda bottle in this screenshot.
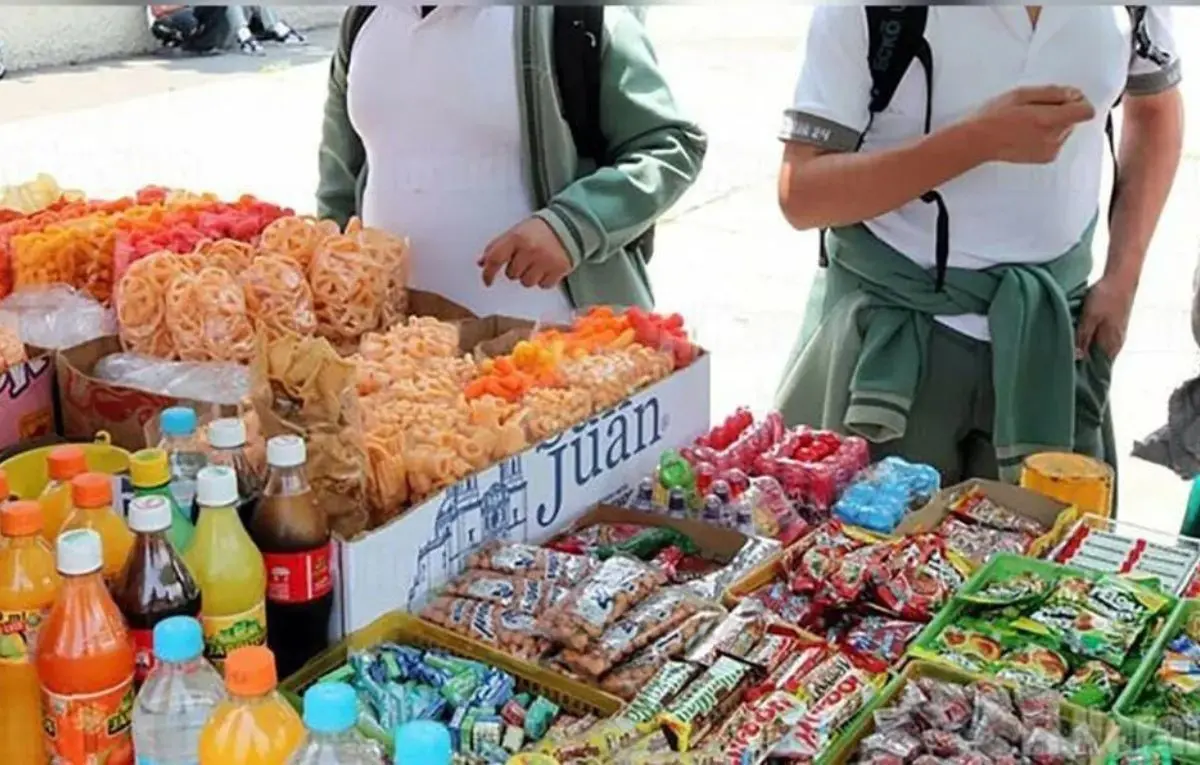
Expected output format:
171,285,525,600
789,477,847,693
42,675,133,765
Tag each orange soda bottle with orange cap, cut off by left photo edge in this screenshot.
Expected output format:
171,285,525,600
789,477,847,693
0,501,61,765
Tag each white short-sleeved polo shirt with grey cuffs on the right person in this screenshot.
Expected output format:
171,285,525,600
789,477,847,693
781,6,1181,339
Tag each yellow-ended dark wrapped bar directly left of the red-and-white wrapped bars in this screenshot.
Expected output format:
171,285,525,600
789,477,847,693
659,656,761,752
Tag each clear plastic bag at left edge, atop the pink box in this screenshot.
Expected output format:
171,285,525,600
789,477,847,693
0,284,116,350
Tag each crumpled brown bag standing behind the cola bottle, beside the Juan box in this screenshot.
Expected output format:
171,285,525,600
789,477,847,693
251,335,368,538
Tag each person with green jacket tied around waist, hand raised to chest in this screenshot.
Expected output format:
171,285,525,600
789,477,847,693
779,6,1183,483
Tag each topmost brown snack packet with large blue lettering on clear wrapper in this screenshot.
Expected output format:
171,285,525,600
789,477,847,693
538,555,666,651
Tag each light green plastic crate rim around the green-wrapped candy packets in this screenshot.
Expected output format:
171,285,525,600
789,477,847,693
908,554,1178,709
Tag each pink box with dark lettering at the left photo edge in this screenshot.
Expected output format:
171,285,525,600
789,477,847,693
0,345,55,451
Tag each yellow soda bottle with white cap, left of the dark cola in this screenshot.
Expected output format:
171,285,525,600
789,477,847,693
184,466,267,671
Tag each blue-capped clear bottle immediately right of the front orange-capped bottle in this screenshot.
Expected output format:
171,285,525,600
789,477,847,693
288,682,384,765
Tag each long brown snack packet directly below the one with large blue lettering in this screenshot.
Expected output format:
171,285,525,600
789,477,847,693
560,588,703,677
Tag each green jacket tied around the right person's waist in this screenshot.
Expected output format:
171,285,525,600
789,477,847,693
779,223,1115,480
